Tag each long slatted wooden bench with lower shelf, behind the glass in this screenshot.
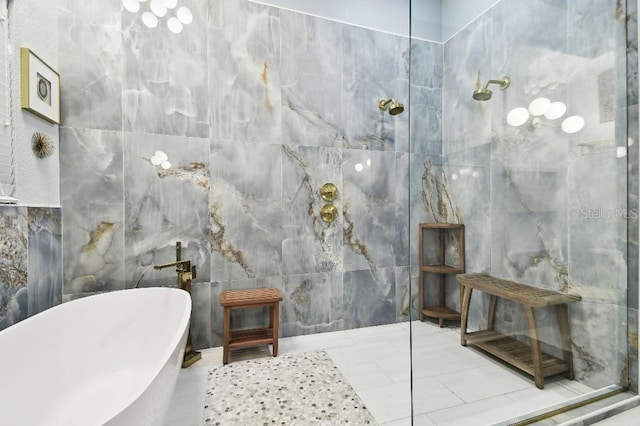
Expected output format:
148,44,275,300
456,274,581,389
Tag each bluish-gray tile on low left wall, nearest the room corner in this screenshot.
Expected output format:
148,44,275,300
27,207,62,316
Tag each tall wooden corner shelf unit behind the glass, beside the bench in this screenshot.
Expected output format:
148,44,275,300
418,223,464,327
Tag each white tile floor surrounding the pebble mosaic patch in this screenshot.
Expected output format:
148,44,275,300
166,322,604,426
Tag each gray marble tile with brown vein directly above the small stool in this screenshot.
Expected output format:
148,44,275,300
208,144,282,280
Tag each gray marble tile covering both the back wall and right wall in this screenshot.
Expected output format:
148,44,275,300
50,0,637,392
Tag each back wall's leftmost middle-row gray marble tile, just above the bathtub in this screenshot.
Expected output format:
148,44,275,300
60,127,124,295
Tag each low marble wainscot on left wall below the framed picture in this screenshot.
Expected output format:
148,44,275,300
0,206,62,330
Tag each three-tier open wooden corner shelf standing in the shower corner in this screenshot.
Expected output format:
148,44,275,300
418,223,464,327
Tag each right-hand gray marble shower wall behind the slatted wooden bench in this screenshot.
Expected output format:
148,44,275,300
442,0,638,387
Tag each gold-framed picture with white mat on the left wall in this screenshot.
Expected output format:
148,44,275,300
20,47,60,124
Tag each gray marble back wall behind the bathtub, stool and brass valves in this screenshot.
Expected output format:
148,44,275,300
60,0,442,347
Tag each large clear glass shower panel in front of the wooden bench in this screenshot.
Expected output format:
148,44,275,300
409,0,637,424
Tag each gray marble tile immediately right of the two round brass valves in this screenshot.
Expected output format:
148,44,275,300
342,150,397,271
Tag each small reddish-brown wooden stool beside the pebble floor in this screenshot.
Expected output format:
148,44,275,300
220,288,282,364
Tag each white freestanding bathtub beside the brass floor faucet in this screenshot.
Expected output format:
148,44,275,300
0,288,191,426
